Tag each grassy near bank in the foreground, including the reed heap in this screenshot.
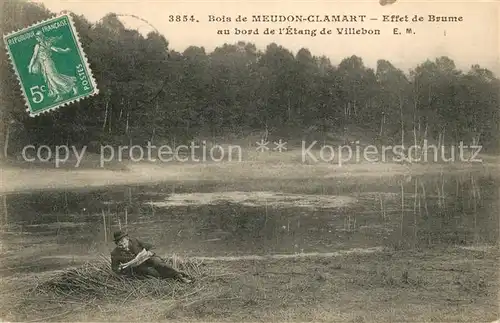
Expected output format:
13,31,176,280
1,247,499,322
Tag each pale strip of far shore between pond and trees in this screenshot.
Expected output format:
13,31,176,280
0,154,494,193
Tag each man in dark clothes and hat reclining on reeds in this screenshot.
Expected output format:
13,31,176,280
111,231,191,283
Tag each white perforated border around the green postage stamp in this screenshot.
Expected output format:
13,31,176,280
3,12,99,117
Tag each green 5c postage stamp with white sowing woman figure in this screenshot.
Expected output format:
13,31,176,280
3,14,99,117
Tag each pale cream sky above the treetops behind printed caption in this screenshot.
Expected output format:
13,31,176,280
33,0,500,75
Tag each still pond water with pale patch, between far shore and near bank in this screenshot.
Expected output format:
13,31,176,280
0,173,500,275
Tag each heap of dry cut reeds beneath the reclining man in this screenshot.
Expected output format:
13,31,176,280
11,255,231,320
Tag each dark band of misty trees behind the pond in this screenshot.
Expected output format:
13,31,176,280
0,0,499,157
